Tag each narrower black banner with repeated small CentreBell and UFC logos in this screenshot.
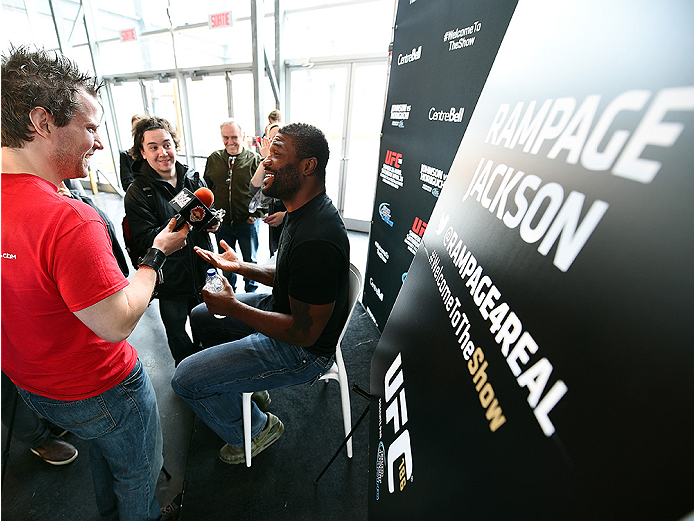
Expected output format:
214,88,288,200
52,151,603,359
362,0,516,330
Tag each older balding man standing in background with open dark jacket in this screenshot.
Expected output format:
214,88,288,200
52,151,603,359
205,119,265,293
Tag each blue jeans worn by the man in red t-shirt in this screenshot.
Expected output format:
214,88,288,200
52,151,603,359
18,360,164,521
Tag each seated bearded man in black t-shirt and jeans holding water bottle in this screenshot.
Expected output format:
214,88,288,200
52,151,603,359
171,124,349,464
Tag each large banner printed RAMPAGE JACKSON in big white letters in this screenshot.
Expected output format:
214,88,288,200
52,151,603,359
369,0,694,520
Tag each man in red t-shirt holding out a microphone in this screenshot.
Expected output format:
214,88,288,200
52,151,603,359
1,47,188,521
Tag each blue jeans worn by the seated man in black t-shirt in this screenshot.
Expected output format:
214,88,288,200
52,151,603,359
171,293,332,447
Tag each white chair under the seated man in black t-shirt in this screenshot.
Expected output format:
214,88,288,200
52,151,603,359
243,264,362,467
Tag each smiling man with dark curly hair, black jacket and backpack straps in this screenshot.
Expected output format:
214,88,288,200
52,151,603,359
125,117,219,365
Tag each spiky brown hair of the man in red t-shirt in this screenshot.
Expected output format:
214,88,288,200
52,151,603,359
0,45,103,148
